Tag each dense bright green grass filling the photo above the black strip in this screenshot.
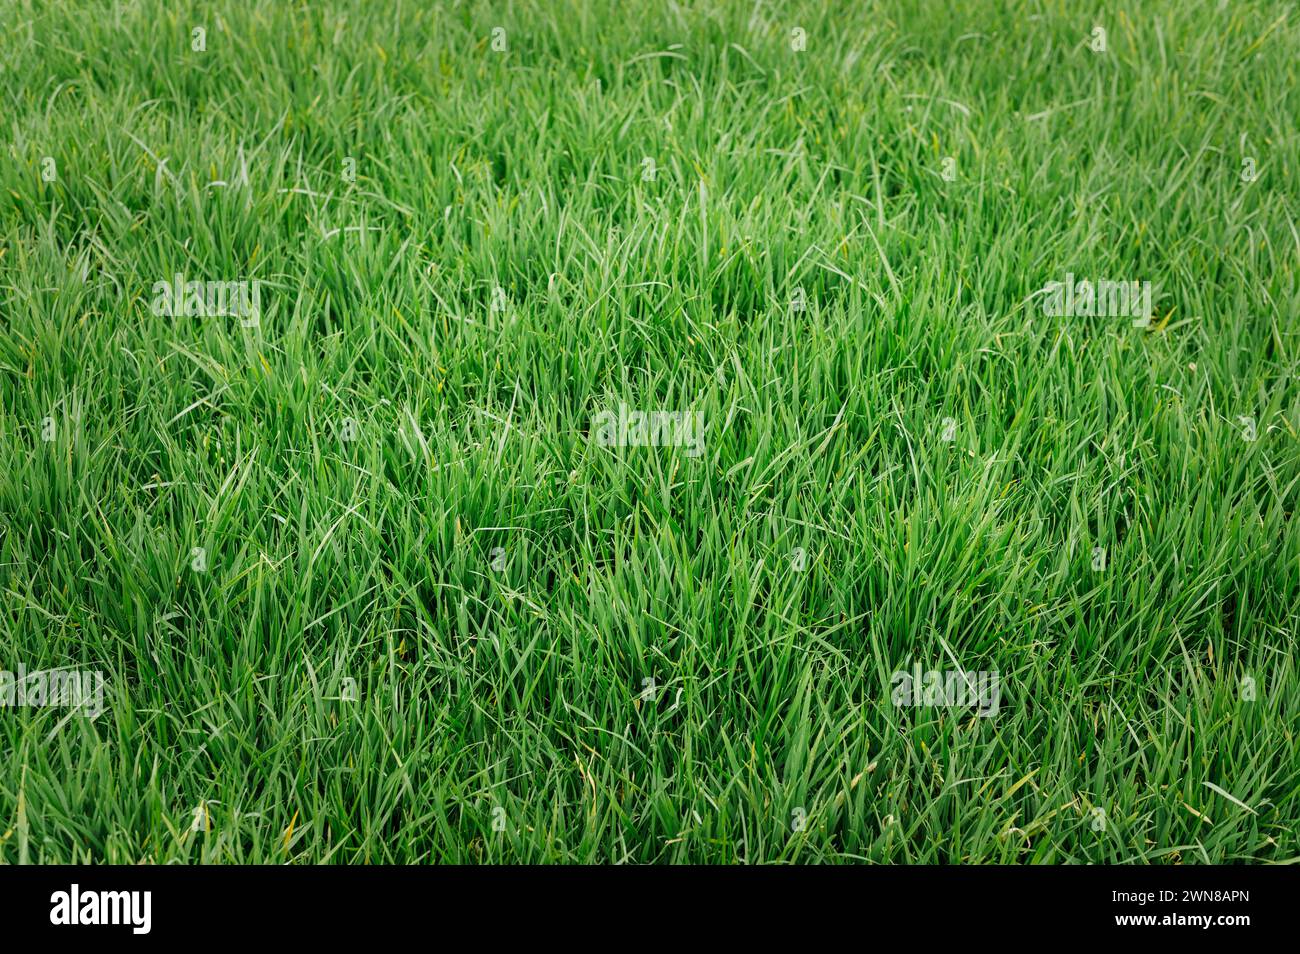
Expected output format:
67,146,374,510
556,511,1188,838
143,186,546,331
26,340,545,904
0,0,1300,864
